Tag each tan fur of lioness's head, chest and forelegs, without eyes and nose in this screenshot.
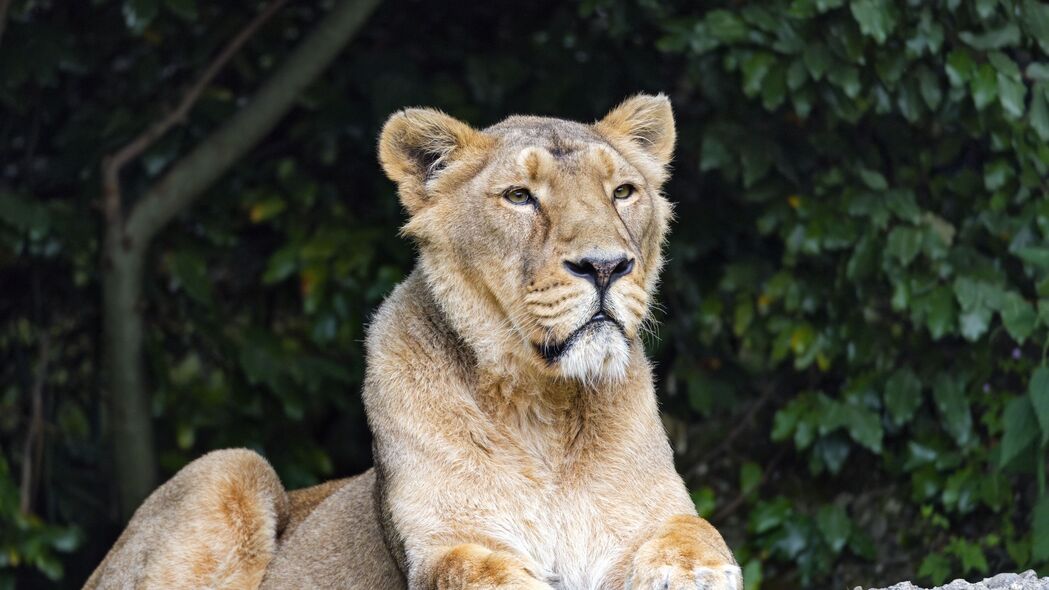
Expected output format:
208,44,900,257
364,97,742,589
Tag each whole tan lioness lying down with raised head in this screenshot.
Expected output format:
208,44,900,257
88,96,742,590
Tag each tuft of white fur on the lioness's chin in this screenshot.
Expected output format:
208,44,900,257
557,325,630,383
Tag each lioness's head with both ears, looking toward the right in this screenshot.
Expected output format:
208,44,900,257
379,96,675,381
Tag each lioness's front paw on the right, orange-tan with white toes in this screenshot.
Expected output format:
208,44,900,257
626,514,743,590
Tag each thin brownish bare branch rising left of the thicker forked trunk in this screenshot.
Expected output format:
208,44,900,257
101,0,287,226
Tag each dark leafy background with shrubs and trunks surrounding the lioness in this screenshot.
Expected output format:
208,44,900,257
0,0,1049,590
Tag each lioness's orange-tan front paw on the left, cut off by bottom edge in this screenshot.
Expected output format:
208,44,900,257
425,543,552,590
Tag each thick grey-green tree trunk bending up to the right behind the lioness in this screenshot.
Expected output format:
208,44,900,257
102,0,380,519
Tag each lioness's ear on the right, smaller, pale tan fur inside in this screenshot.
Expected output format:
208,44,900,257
595,93,677,166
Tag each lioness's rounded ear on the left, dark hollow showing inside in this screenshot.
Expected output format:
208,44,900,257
379,108,484,213
